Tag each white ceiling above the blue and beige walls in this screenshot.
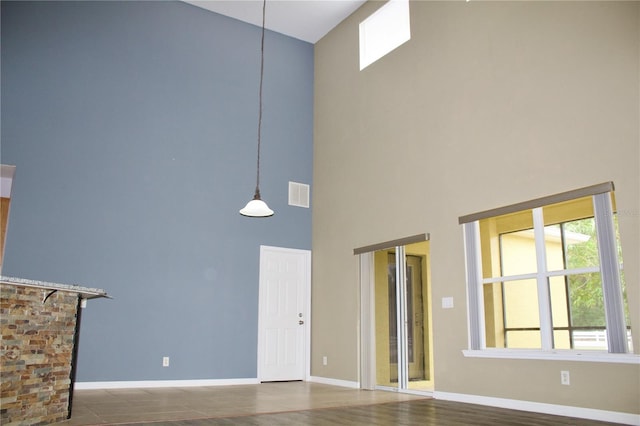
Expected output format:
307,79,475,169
183,0,366,44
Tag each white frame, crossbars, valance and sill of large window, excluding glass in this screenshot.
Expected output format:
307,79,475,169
459,182,640,364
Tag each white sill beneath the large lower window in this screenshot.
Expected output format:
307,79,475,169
462,349,640,364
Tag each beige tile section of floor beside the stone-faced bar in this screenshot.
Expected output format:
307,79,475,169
62,382,424,426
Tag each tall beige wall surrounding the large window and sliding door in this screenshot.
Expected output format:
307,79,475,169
312,1,640,413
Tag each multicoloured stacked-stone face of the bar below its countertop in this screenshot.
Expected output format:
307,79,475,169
0,284,78,425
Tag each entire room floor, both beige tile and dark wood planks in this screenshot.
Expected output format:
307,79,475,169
64,382,624,426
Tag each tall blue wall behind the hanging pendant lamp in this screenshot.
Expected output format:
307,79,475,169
0,1,313,382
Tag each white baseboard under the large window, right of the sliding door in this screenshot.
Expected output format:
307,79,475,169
433,391,640,426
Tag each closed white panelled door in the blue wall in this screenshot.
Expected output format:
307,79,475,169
258,246,311,382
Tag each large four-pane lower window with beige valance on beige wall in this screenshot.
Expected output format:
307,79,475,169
460,183,633,353
